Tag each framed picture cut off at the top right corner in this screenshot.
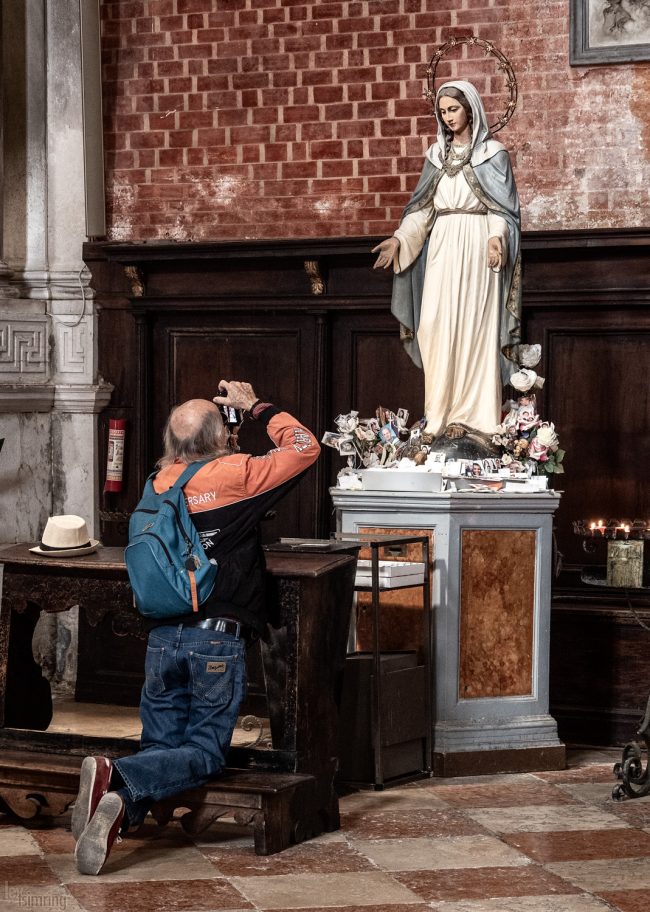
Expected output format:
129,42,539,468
569,0,650,66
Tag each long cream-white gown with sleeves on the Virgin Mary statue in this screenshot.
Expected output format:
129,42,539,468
395,164,508,435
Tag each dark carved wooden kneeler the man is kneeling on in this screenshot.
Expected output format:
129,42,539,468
0,543,357,854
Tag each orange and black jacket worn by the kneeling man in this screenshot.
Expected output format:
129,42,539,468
147,405,320,634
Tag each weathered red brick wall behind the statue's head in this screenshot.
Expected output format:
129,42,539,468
101,0,650,240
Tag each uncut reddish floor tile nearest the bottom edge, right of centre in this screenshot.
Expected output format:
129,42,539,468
393,865,582,902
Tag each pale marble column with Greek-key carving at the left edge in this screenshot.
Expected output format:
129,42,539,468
0,0,111,542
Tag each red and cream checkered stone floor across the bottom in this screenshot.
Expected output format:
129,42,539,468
0,751,650,912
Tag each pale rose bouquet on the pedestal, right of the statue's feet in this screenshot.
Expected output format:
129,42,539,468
492,394,564,475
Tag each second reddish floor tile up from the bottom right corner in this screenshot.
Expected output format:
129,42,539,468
501,829,650,864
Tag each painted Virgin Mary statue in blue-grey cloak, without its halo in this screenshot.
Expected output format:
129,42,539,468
373,81,521,438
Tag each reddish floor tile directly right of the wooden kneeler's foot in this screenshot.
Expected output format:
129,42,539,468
341,810,488,839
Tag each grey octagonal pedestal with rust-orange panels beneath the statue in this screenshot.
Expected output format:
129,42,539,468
330,487,565,776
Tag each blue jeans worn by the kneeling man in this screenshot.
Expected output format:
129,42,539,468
113,624,246,825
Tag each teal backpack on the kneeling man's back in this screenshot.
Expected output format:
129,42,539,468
124,460,217,620
